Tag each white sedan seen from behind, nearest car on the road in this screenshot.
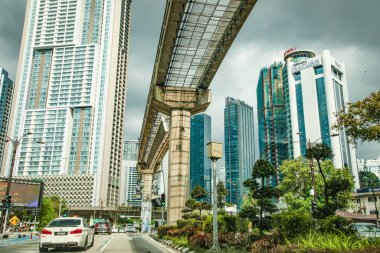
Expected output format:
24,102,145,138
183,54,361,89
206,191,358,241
39,217,94,252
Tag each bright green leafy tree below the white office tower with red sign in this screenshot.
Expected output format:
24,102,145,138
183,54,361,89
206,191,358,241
277,158,354,218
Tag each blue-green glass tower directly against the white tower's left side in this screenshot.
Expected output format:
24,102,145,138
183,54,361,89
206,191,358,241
256,63,288,185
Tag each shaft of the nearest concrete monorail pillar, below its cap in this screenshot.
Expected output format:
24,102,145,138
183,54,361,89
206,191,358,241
167,109,191,224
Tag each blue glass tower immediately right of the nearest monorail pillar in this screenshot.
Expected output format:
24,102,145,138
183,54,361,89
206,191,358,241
190,114,212,202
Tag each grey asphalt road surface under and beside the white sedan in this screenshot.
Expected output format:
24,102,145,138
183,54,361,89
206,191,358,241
0,233,176,253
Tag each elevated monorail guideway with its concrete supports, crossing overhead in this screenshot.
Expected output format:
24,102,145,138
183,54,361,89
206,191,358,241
138,0,256,224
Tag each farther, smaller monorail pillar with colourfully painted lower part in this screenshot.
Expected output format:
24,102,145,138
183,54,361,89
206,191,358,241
141,171,153,233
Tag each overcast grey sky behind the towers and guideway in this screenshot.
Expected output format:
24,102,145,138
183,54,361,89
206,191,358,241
0,0,380,159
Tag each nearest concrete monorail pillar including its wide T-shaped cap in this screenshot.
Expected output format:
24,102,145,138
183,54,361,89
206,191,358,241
147,86,211,224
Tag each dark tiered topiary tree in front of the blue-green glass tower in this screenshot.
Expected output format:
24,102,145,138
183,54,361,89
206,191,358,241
243,160,277,231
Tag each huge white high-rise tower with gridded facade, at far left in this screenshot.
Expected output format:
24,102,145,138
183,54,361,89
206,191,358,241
2,0,131,206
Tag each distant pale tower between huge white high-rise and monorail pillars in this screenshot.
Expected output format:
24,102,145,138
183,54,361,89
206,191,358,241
119,140,141,206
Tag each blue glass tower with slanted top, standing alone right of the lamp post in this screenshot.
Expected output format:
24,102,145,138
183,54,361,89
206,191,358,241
224,97,255,206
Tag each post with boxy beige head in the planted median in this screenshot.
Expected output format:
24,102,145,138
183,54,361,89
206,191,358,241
207,142,222,252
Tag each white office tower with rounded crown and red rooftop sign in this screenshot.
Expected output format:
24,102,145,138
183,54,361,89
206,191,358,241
283,48,359,188
